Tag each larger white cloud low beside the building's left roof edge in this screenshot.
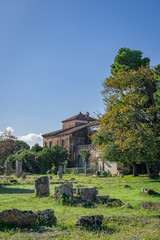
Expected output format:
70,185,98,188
18,133,43,146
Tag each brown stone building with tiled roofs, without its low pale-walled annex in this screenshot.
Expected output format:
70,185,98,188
42,112,98,167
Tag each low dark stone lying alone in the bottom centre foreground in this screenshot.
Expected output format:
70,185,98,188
75,215,103,227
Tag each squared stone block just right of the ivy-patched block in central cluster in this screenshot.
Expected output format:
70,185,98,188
76,187,98,201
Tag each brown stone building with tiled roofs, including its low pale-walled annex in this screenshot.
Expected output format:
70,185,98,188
42,112,130,174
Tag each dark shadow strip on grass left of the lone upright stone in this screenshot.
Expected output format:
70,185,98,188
0,186,34,194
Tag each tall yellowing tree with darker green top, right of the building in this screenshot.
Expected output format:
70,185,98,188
94,49,160,177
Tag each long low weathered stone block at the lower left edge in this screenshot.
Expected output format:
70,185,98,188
0,209,37,227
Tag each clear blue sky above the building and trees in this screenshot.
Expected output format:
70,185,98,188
0,0,160,144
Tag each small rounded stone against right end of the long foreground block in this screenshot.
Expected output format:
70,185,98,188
36,209,57,226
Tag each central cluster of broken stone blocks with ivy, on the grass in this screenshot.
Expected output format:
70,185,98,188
54,183,109,206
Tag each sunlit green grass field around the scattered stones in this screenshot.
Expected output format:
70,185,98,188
0,174,160,240
